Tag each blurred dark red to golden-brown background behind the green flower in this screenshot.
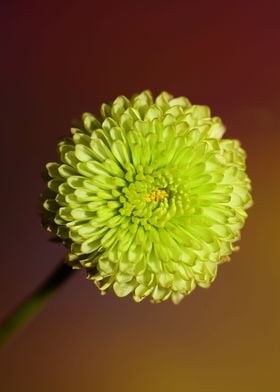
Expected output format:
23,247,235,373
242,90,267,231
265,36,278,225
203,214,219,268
0,0,280,392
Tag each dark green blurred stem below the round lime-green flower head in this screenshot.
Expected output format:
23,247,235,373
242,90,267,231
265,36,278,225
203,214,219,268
0,261,73,347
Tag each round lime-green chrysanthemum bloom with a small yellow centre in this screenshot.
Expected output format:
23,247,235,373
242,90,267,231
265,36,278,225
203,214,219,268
42,91,252,303
